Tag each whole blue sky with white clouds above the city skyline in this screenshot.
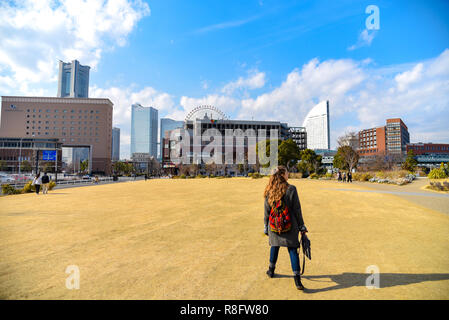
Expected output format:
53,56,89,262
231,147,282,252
0,0,449,157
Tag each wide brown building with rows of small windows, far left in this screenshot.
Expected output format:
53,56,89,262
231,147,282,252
0,96,113,174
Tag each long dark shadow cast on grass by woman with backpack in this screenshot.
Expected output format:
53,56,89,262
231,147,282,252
276,272,449,293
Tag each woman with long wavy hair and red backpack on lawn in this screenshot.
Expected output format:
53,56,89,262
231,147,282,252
264,166,307,290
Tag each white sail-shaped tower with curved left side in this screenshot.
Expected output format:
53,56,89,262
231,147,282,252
302,101,330,149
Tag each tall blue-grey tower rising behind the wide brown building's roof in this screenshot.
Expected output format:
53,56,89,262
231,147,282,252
58,60,90,98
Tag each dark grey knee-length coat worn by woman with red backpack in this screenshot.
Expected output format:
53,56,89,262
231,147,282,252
264,184,306,248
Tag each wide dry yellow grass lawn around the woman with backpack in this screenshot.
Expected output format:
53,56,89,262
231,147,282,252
0,178,449,299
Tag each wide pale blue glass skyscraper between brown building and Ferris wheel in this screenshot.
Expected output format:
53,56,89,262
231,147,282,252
131,103,158,158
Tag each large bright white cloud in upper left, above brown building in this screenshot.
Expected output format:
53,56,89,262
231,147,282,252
0,0,150,95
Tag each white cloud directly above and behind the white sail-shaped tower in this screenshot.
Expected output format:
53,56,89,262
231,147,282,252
239,59,365,125
